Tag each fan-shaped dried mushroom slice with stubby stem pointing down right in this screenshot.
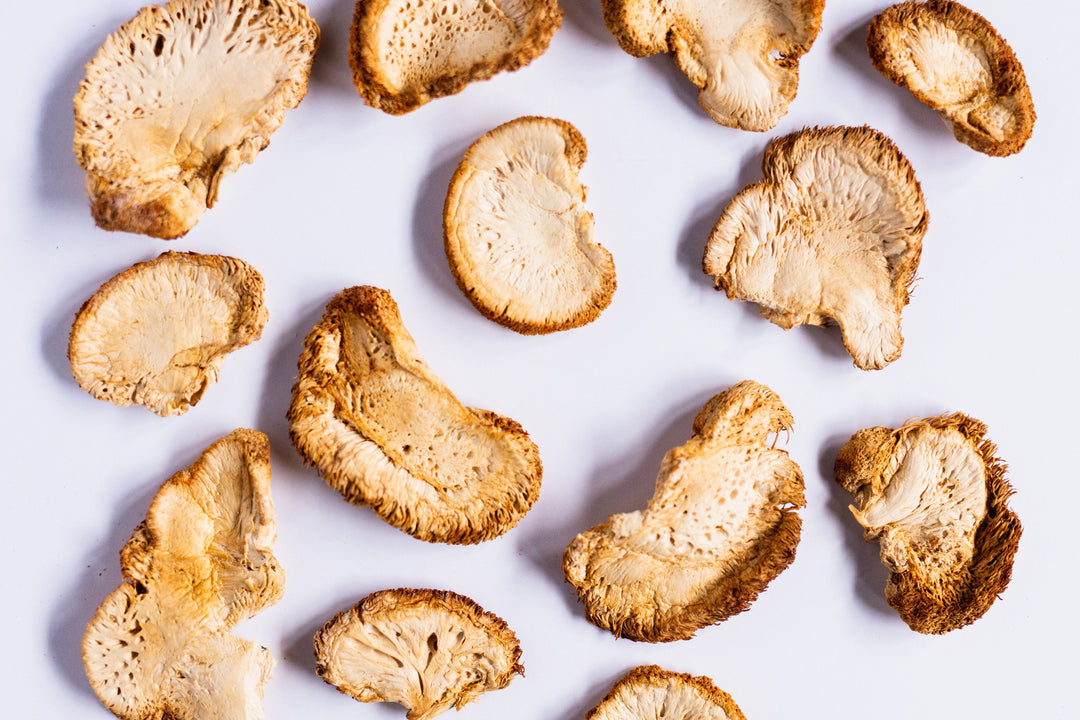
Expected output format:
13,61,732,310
702,127,929,370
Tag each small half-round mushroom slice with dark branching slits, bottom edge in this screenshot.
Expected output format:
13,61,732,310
315,589,525,720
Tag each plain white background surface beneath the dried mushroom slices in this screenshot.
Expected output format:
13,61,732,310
0,0,1080,720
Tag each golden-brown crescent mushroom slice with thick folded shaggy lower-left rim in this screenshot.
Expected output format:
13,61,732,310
288,286,542,544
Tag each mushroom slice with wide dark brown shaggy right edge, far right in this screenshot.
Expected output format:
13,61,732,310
836,413,1021,634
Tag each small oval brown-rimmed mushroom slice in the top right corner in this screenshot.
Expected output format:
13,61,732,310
866,0,1035,155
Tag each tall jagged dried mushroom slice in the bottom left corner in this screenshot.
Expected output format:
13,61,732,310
82,430,285,720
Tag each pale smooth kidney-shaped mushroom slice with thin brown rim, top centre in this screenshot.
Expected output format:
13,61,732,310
443,118,616,334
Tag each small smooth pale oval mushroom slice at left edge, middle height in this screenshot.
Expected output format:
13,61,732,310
68,253,268,416
